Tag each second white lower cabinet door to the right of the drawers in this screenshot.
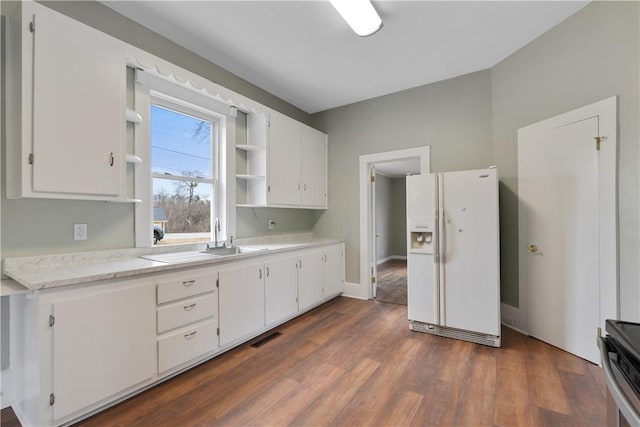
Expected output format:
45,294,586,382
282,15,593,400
264,256,298,325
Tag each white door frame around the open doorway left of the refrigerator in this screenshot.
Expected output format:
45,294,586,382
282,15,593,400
354,145,431,299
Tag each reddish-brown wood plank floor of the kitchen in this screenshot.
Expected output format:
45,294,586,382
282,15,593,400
2,297,606,427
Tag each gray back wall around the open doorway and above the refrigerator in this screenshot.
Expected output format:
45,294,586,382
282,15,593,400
313,70,493,283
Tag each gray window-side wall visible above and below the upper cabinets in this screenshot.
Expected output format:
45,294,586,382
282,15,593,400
0,1,313,258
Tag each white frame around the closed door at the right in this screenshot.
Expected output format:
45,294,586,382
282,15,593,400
518,96,619,339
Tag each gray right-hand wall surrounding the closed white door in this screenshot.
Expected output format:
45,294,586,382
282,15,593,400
491,2,640,319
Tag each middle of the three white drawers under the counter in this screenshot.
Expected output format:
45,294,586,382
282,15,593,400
158,292,218,334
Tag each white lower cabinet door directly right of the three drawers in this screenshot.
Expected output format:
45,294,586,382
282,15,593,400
218,263,265,346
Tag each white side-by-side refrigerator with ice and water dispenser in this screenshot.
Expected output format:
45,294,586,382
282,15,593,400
407,168,500,347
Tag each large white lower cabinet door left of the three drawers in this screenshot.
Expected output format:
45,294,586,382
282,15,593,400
52,285,156,420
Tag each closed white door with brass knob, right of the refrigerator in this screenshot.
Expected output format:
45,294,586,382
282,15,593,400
518,105,616,363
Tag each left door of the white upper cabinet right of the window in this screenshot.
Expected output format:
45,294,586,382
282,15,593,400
267,114,301,206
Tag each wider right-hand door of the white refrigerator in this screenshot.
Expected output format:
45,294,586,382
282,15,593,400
438,169,500,336
